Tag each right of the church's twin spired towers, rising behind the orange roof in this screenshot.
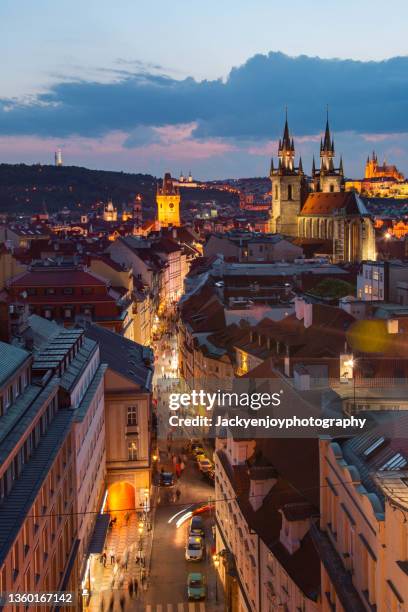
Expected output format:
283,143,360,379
312,113,344,193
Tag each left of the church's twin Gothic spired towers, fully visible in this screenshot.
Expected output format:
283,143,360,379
269,116,306,236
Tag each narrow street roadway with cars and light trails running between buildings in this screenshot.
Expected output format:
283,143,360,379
143,318,224,612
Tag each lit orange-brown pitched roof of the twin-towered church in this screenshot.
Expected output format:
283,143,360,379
300,191,368,215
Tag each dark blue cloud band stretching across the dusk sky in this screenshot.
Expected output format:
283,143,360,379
0,53,408,141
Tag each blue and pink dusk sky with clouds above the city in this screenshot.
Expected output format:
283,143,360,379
0,0,408,179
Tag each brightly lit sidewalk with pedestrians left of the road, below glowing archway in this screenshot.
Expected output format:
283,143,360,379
86,504,154,612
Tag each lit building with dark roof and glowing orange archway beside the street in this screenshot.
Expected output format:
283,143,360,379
86,325,153,522
